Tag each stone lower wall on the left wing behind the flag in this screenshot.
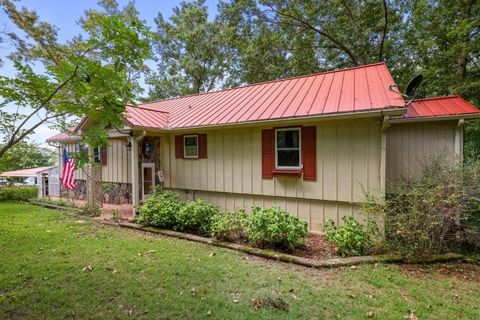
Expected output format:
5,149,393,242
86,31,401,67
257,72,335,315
62,180,132,204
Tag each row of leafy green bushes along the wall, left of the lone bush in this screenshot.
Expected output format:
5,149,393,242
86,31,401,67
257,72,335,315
137,191,308,250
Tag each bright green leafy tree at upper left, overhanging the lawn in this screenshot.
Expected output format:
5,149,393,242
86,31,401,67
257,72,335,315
0,0,150,157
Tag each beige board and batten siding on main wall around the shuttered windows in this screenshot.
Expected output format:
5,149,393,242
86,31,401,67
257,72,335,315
161,118,381,230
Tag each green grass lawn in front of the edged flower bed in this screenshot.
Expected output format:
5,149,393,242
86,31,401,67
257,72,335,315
0,203,480,319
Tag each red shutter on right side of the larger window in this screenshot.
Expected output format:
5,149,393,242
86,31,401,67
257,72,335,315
302,126,317,180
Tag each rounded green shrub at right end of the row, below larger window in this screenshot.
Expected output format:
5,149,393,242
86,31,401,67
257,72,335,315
244,207,308,250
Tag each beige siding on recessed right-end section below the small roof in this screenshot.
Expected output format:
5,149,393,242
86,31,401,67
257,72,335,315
386,120,463,192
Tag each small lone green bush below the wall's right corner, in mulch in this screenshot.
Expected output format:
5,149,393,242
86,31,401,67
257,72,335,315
325,216,378,257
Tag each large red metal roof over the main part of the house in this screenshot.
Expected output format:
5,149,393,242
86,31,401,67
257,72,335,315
137,63,405,128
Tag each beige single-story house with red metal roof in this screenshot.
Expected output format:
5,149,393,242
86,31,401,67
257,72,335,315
48,63,480,231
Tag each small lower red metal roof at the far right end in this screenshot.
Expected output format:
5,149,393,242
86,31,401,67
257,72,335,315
404,96,480,119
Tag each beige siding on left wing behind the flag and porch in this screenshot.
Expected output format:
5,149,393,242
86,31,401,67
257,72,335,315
66,139,132,183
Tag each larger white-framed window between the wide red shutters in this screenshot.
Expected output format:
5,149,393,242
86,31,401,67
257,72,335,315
275,128,300,169
